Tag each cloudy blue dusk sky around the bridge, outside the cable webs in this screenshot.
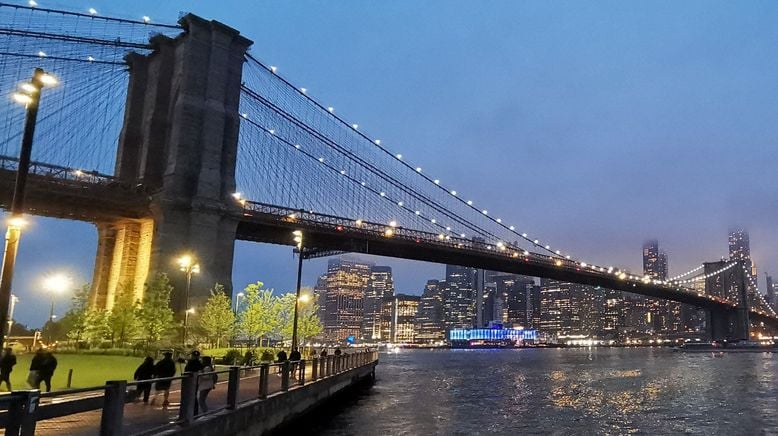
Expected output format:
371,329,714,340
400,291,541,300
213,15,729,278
3,0,778,326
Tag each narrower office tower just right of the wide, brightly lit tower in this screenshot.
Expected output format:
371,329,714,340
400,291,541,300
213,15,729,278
362,266,394,341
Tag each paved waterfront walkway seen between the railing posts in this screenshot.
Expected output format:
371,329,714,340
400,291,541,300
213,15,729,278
28,363,311,436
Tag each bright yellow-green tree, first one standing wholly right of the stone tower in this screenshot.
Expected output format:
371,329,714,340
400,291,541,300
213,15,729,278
238,282,277,343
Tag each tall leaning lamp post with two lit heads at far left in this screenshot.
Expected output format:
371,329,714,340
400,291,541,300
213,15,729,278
0,68,57,348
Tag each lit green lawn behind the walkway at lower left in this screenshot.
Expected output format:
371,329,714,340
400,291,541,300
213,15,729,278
0,353,177,391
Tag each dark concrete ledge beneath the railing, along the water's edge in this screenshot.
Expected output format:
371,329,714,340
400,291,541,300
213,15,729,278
160,361,378,436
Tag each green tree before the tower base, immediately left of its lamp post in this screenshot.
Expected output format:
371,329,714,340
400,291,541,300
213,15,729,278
138,273,173,344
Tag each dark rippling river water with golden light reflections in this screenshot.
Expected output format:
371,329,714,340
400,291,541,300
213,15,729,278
304,348,778,435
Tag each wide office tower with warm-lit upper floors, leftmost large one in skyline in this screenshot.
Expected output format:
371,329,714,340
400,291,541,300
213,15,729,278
322,258,373,341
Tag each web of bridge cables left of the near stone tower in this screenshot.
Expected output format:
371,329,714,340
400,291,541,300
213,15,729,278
0,3,182,174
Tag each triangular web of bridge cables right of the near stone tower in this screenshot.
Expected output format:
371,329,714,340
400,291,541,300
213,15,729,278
237,56,584,257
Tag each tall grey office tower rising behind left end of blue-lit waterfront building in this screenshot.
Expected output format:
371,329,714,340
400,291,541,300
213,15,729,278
443,265,476,331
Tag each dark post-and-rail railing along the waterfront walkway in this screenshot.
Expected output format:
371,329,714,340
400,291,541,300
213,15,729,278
0,351,378,435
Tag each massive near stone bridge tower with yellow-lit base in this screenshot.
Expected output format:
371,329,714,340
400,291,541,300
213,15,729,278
92,14,252,311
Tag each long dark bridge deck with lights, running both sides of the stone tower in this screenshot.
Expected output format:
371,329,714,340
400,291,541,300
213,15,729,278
0,162,778,328
